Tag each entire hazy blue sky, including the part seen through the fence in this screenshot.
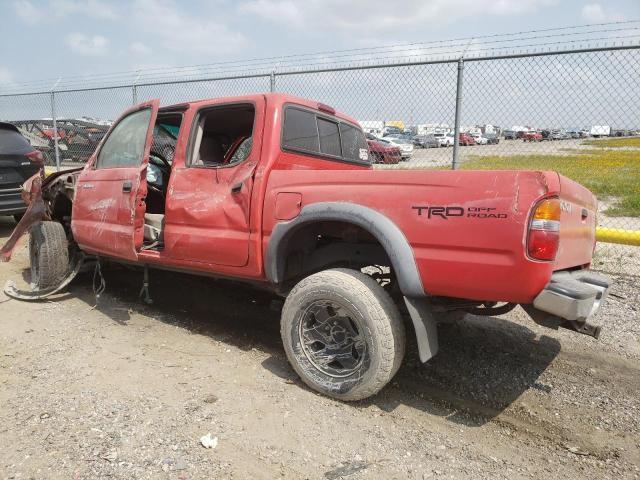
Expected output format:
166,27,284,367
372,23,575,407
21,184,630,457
0,0,640,128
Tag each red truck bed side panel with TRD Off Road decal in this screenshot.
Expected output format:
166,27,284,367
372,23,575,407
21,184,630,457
263,163,559,303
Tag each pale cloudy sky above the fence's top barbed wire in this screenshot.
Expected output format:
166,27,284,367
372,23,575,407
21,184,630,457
0,0,640,85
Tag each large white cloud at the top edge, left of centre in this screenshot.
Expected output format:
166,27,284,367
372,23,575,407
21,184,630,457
131,0,248,56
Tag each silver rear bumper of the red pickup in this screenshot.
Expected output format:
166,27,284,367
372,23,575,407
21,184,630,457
523,270,612,338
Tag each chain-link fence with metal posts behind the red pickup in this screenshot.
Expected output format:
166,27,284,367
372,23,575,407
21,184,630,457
0,46,640,273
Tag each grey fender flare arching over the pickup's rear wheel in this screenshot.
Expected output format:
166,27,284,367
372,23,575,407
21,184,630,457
265,202,425,297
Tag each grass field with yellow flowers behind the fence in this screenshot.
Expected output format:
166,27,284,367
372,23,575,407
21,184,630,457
462,148,640,217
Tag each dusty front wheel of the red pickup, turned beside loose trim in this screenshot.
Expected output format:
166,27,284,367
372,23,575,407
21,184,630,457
29,222,69,290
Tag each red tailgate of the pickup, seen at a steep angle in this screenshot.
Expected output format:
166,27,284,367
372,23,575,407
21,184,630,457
555,175,597,270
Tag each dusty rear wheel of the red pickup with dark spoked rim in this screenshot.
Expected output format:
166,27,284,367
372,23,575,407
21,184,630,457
280,268,405,401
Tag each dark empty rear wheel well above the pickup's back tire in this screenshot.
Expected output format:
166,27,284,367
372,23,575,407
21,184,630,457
282,221,393,290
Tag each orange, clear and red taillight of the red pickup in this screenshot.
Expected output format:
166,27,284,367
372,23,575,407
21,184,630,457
527,198,560,261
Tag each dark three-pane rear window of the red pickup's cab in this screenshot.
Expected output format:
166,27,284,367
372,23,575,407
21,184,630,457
281,105,370,165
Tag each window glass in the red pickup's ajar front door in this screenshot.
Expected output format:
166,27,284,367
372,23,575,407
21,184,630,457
96,108,151,168
